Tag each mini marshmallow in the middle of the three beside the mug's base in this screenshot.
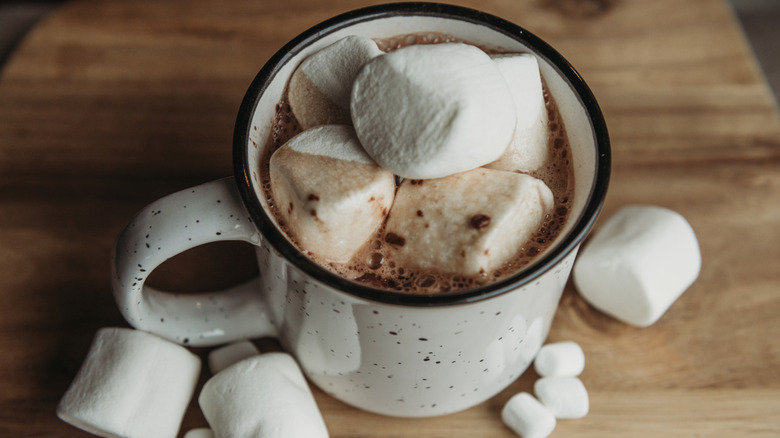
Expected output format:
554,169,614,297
534,377,590,418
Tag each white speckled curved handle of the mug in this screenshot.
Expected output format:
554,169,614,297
111,177,276,346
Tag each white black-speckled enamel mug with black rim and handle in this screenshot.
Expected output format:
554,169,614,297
112,3,610,417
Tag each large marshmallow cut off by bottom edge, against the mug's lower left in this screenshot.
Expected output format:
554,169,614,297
198,353,328,438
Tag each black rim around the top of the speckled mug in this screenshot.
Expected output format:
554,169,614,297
233,2,611,307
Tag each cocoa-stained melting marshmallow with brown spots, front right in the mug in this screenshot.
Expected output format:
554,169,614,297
385,168,554,275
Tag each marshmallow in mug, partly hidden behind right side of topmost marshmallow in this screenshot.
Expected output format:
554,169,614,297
485,53,549,172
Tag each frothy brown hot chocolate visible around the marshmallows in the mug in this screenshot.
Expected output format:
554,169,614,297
259,33,574,294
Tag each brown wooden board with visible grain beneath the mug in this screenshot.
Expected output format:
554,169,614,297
0,0,780,438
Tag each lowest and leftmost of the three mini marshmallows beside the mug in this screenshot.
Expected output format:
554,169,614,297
501,392,556,438
